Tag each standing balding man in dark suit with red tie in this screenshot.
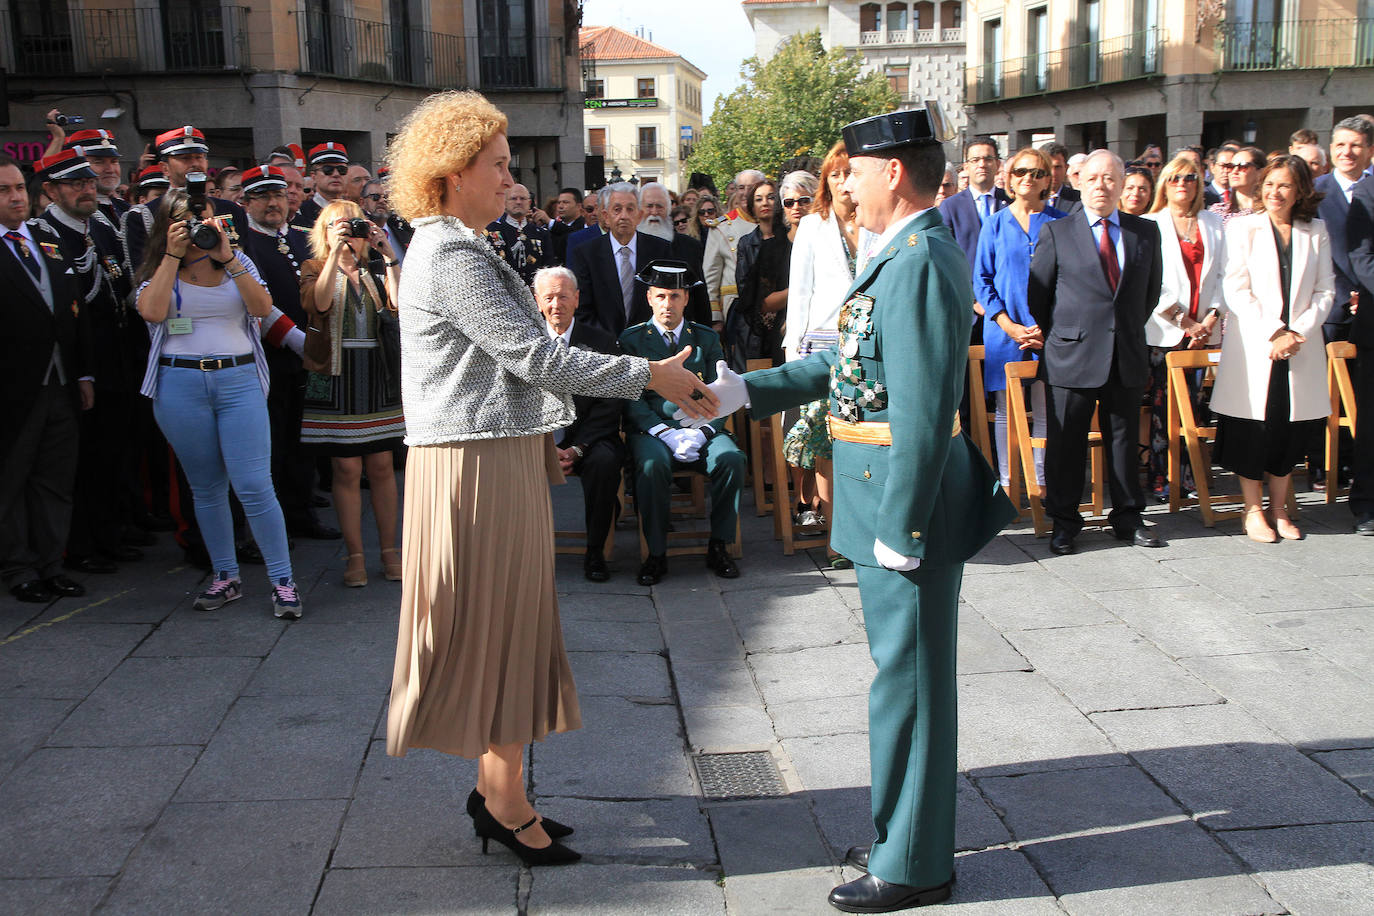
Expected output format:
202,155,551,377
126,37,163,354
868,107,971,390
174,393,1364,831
1028,150,1164,553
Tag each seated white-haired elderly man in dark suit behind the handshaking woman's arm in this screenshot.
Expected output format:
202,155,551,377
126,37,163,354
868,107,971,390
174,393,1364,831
534,268,625,582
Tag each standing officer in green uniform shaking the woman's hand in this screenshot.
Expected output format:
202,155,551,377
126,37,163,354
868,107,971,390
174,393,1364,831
678,103,1015,913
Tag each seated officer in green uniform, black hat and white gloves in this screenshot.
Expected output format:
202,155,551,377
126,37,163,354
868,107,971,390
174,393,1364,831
620,258,745,585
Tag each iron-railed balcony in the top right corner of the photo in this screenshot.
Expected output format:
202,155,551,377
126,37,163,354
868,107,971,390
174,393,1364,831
1216,19,1374,71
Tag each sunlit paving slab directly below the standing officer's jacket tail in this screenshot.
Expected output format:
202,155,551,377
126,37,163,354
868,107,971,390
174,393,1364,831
960,566,1116,632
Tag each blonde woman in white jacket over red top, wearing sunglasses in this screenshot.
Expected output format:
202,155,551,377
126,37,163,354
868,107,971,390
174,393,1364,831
1145,155,1226,503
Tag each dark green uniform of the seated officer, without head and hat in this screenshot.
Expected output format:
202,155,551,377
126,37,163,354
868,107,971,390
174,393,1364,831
620,319,747,556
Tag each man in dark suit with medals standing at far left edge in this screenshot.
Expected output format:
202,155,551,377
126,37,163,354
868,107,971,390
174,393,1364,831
0,157,95,603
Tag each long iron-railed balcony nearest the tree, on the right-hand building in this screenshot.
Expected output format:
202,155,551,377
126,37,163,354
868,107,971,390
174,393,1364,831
965,29,1168,104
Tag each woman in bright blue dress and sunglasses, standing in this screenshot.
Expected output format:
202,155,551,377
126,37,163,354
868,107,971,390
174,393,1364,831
973,147,1063,486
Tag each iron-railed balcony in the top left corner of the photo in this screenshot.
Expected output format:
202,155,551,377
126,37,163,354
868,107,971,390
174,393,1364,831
0,5,250,77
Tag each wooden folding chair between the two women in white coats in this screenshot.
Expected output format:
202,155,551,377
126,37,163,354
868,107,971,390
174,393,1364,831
1164,350,1245,527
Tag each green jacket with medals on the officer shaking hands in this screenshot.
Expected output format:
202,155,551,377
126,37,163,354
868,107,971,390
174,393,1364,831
745,209,1015,566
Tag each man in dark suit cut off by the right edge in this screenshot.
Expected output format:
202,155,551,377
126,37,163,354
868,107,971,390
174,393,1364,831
1318,117,1374,536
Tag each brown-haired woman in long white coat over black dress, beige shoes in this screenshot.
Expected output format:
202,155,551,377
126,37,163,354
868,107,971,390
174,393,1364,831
1212,155,1334,544
